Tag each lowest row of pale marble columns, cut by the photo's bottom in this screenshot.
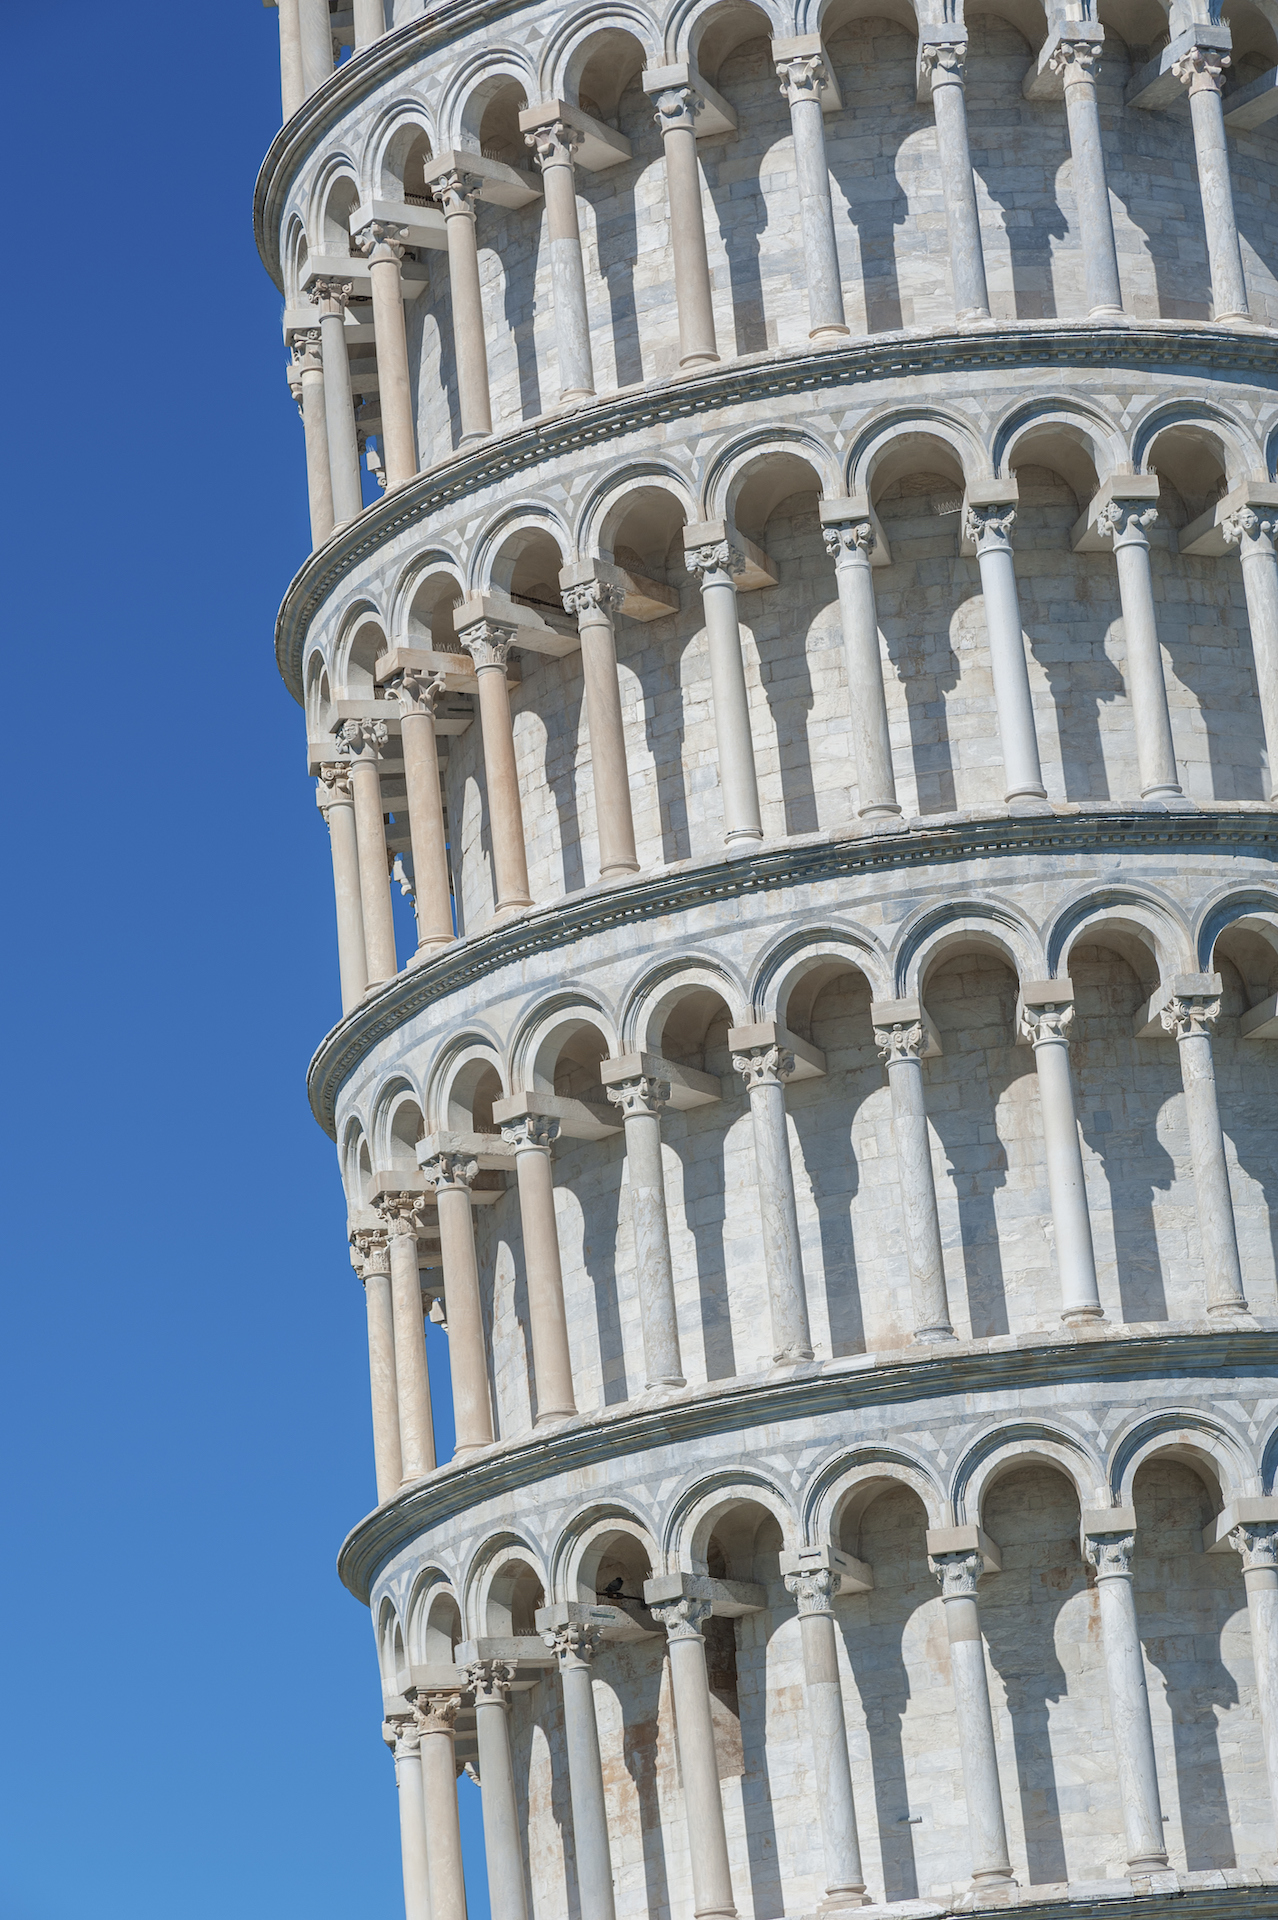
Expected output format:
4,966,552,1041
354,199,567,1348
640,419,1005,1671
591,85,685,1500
384,1500,1278,1920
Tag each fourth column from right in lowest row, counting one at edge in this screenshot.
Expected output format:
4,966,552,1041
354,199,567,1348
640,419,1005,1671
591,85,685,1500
785,1567,865,1912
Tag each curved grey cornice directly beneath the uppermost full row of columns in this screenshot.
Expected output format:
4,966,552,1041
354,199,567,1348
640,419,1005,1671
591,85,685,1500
274,321,1278,705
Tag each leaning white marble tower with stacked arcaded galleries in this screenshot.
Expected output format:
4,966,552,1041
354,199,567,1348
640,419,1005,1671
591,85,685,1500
255,0,1278,1920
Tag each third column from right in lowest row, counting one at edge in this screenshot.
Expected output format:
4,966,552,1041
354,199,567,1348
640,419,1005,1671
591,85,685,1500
933,1551,1015,1887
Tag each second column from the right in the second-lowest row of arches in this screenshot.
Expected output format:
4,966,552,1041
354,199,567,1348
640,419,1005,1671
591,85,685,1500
1021,981,1105,1323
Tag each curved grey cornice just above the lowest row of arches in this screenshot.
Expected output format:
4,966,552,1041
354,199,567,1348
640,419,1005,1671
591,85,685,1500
338,1327,1278,1605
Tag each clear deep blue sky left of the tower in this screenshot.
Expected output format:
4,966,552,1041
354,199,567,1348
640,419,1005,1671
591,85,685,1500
0,0,487,1920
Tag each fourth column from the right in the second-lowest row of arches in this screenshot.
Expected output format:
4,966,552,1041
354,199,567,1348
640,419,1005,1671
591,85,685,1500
733,1046,812,1365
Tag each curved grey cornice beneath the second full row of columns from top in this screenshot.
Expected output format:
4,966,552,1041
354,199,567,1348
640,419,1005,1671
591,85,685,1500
307,806,1278,1140
